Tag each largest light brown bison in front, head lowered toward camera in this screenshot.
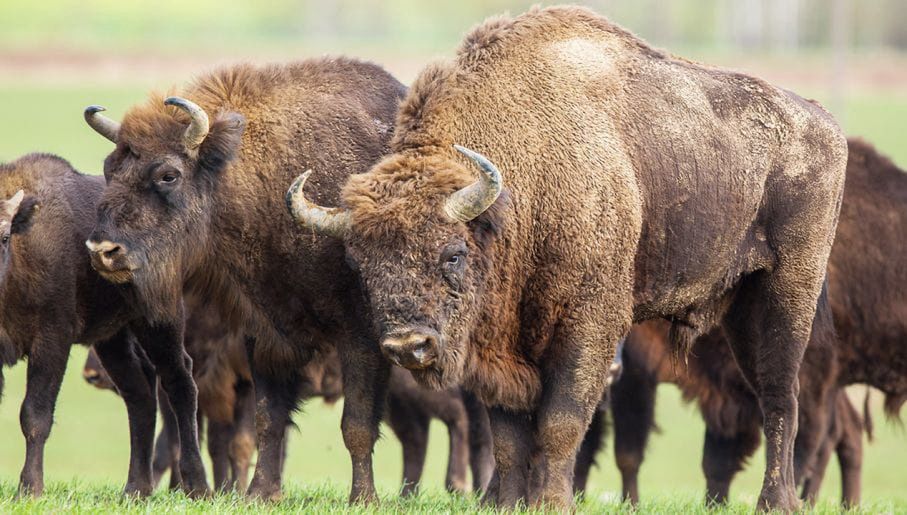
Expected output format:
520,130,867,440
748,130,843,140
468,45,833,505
288,7,847,509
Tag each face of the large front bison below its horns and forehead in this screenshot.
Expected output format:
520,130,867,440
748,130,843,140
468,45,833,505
346,223,478,388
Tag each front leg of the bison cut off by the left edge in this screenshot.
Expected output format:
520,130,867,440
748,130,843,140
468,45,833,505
19,337,70,497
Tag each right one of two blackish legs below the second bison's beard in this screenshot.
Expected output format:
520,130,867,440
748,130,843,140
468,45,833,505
133,319,211,497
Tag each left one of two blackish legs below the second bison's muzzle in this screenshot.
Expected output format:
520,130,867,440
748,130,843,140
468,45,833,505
94,330,157,496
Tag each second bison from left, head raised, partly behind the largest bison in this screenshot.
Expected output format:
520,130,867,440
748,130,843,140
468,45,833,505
81,58,405,500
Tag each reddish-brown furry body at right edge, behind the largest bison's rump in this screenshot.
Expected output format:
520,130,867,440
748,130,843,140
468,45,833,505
828,138,907,417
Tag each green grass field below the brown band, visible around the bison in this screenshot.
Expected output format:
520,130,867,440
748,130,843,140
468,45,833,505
0,82,907,513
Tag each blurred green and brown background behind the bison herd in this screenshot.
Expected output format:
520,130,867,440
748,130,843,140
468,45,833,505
0,0,907,508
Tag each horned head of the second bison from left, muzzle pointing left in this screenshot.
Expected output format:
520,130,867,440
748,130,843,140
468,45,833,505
85,97,245,318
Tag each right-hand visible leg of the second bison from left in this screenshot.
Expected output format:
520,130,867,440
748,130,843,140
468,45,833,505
338,339,390,503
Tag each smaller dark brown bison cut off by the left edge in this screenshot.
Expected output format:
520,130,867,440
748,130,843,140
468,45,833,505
0,154,166,496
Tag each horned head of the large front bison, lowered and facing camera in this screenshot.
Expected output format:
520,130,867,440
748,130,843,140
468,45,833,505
287,146,503,388
